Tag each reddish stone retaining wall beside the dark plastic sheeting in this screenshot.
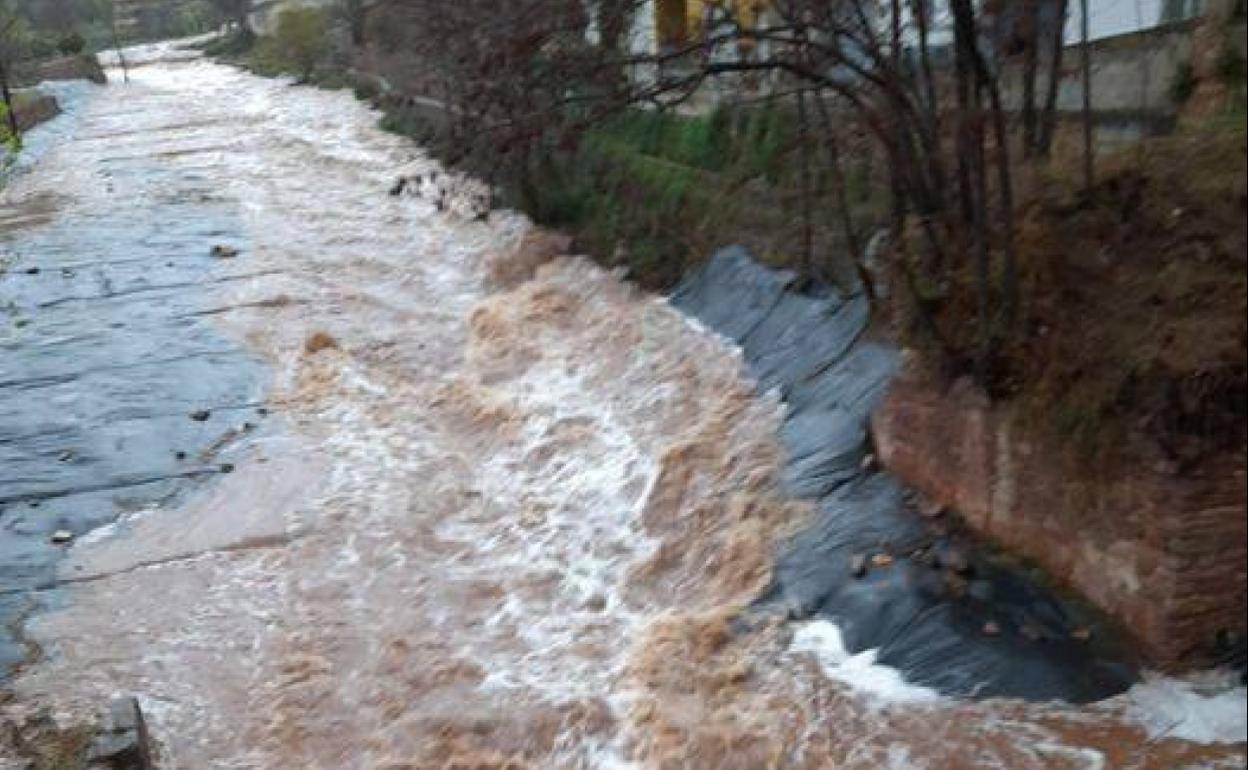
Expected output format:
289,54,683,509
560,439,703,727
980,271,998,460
872,376,1248,670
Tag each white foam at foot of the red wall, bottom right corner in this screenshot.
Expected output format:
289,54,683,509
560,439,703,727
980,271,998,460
1126,671,1248,744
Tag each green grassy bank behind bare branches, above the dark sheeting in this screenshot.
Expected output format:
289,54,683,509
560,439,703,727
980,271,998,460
381,102,882,288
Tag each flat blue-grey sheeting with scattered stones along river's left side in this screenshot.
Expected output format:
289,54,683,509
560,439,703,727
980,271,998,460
0,81,263,678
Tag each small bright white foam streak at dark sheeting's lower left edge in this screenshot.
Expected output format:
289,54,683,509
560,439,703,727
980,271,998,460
789,619,941,703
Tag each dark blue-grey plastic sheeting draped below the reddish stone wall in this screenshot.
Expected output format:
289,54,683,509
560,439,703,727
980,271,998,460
673,247,1136,703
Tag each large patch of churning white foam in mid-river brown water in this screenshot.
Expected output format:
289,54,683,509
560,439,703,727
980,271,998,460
439,367,655,699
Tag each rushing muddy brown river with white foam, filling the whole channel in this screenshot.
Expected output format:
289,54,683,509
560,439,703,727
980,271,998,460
0,47,1244,770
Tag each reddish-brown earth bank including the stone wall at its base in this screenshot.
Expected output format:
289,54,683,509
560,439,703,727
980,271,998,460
874,127,1248,668
